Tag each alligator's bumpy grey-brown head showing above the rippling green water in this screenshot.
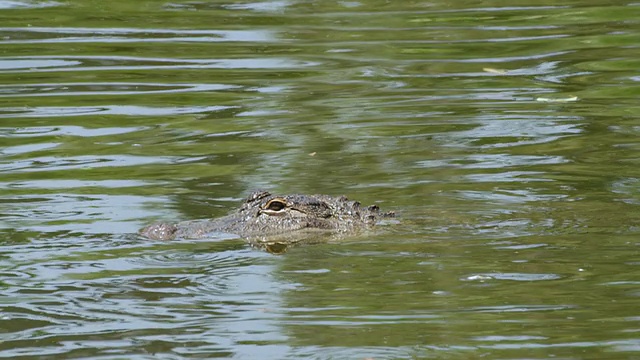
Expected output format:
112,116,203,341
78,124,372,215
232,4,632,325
140,191,394,250
